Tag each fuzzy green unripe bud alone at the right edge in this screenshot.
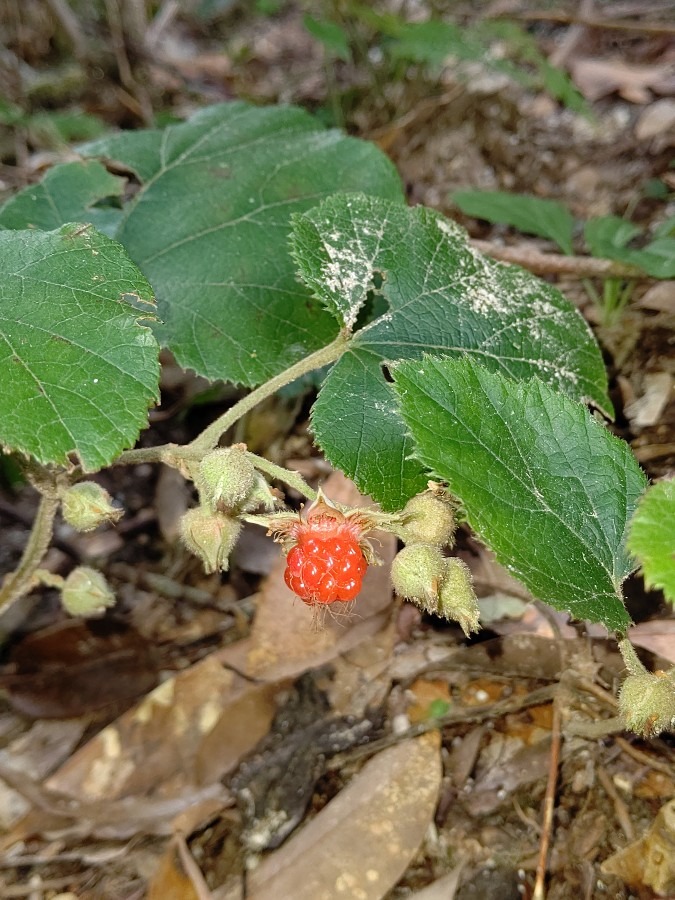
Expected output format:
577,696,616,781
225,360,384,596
619,669,675,737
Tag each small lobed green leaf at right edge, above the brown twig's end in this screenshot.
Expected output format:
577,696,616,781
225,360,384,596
584,216,675,278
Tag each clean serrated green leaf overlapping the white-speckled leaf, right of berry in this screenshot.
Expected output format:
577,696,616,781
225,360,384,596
394,357,646,630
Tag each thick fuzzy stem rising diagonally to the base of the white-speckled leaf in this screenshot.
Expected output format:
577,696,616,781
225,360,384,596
114,331,351,472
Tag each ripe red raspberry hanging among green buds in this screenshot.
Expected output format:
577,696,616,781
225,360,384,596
284,488,368,606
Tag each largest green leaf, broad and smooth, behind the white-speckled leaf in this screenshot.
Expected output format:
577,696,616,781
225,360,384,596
78,102,403,386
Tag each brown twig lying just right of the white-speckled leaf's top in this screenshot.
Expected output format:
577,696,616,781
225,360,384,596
470,240,647,278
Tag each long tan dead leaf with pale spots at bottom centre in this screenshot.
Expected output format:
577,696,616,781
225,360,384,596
248,732,441,900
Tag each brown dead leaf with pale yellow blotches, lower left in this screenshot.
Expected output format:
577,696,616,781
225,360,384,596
46,656,274,803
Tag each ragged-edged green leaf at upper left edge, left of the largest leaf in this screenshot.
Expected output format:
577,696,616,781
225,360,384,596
0,160,125,237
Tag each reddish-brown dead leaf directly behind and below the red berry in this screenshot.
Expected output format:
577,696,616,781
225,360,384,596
220,472,396,681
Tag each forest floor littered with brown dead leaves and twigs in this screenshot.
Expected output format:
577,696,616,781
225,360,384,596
0,3,675,900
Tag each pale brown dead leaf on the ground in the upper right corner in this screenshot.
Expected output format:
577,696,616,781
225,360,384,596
570,58,675,103
